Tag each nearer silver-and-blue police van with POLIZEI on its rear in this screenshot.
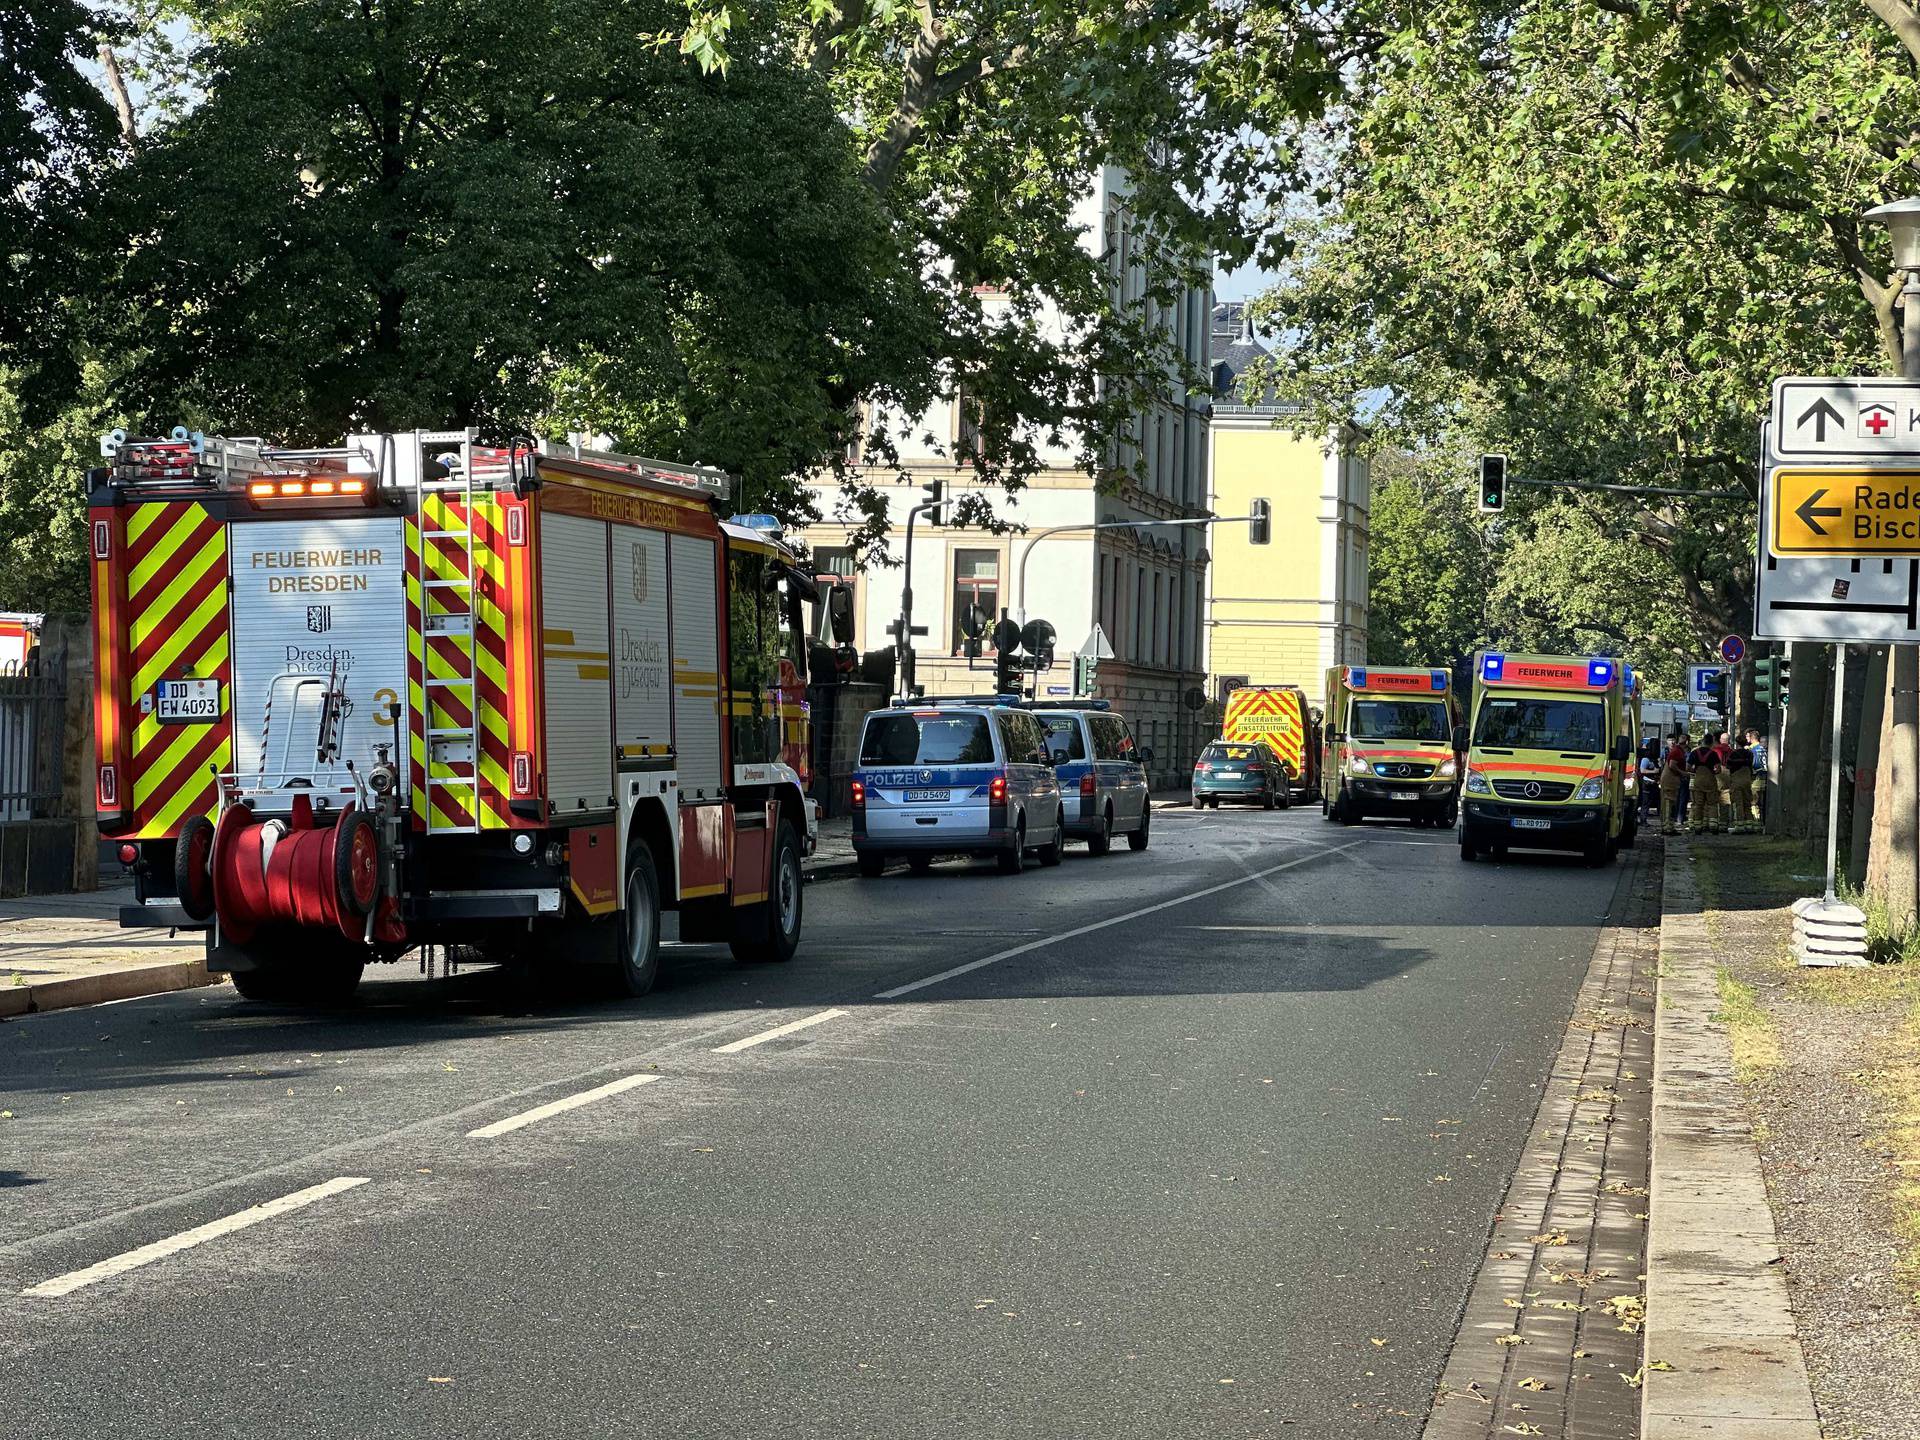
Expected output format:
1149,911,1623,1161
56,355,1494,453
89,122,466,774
852,699,1066,877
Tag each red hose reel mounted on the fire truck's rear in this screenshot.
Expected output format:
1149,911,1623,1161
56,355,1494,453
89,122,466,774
202,795,385,941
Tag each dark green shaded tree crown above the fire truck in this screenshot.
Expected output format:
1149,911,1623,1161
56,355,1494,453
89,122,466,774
94,0,937,511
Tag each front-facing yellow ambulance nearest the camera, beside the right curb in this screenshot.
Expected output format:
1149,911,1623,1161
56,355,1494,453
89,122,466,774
1459,651,1634,866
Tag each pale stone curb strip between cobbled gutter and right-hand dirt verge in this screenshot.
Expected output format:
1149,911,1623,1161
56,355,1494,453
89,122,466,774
1640,837,1820,1440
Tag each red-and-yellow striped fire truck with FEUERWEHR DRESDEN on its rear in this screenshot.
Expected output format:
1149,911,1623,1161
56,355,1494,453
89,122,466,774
88,428,816,1000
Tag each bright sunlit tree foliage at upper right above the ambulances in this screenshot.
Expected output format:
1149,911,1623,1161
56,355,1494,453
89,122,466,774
1267,0,1920,645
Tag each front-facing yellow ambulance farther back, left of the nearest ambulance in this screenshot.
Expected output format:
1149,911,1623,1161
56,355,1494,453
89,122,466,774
1319,664,1459,828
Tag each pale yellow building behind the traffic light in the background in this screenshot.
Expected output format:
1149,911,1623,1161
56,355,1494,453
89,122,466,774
1206,303,1371,707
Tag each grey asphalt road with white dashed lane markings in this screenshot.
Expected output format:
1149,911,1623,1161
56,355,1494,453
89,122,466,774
0,810,1617,1440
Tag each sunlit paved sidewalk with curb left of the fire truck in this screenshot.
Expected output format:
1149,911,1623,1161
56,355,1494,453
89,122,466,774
0,885,217,1018
